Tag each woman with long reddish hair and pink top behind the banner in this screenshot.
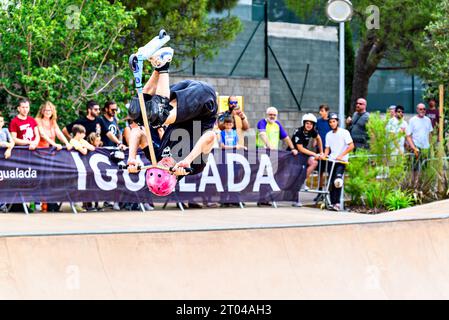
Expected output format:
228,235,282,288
36,101,72,150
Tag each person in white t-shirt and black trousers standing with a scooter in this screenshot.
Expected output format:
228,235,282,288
324,113,354,211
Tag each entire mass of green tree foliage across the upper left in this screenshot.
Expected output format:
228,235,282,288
0,0,242,124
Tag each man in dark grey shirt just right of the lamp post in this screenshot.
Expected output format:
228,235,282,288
346,98,369,149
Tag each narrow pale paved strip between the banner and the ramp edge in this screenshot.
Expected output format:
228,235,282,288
0,200,449,236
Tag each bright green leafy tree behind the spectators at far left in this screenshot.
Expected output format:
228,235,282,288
0,0,141,122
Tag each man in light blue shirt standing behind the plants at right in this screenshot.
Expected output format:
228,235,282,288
407,103,433,179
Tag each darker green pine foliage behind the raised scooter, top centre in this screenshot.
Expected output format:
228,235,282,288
123,0,242,70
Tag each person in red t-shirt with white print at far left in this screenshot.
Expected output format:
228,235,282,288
9,99,41,150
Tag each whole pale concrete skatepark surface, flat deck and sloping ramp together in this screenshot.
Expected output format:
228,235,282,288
0,201,449,299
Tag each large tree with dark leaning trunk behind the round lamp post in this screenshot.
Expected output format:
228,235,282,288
285,0,438,111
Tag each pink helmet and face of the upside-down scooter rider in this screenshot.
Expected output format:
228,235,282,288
146,158,177,197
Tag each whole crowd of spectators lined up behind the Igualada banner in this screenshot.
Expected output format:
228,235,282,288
0,96,440,211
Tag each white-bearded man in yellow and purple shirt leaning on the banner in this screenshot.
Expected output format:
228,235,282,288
256,107,298,156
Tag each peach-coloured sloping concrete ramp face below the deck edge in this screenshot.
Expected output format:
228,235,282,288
0,220,449,299
